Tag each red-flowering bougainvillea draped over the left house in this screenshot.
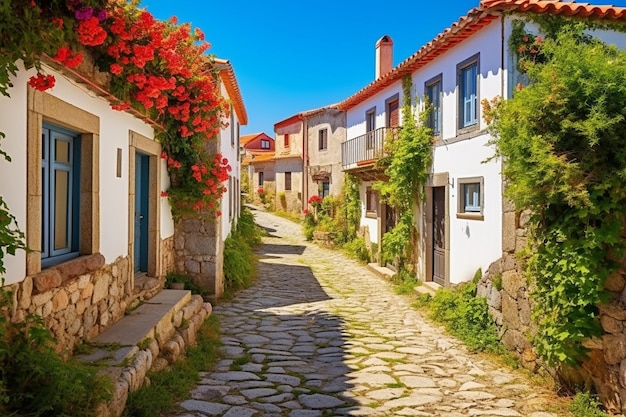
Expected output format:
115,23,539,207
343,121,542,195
0,0,230,216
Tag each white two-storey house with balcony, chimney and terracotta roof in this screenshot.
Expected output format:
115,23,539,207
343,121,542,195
338,0,625,286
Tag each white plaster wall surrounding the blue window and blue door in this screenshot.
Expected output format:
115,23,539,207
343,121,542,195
0,62,174,283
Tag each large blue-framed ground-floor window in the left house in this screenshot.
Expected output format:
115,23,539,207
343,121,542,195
41,124,80,267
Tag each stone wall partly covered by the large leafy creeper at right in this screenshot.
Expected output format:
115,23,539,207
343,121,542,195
477,202,626,413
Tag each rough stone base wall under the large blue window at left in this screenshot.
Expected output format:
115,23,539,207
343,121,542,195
7,237,174,353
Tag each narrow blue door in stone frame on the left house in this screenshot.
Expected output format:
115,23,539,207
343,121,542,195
135,152,150,273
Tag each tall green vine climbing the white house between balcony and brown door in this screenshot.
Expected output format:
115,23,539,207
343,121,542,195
375,75,433,263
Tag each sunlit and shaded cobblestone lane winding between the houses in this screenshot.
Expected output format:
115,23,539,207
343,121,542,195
169,212,567,417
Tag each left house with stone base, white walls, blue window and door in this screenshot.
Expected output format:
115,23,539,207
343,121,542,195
0,52,246,351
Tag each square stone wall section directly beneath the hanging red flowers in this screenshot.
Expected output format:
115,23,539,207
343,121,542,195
174,213,224,298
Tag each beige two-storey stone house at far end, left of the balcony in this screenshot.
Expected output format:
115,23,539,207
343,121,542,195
274,106,345,212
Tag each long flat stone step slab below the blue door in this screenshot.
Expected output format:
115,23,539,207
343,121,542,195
77,290,191,366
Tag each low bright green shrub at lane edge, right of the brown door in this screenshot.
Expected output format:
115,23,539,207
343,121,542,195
428,283,504,353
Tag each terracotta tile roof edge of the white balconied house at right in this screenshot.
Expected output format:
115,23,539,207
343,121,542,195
338,0,626,110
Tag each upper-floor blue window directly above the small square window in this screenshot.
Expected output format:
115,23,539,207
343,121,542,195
457,54,479,128
